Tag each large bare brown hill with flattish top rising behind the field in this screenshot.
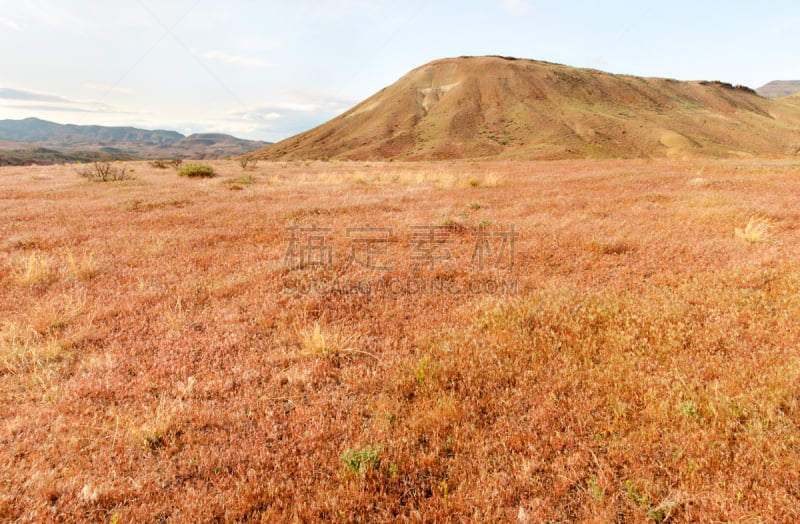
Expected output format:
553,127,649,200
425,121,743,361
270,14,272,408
251,57,800,160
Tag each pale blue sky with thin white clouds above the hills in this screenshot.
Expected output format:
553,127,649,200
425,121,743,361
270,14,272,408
0,0,800,141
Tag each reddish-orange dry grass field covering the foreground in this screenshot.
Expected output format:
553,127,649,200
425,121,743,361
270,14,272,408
0,159,800,522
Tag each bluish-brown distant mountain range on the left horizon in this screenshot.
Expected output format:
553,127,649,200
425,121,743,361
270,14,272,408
0,118,269,165
